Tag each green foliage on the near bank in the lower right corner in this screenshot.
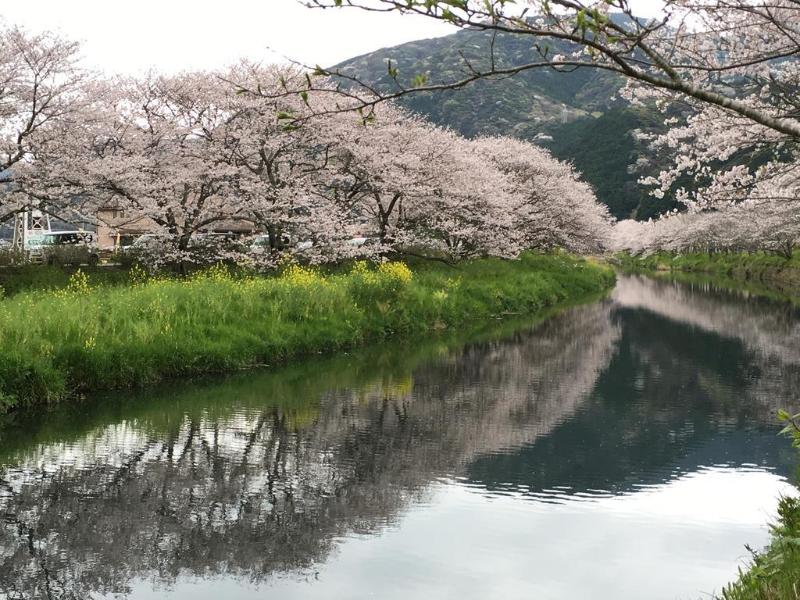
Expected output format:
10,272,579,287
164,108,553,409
722,411,800,600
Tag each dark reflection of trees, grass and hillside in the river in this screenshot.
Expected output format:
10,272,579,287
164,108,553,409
0,278,800,600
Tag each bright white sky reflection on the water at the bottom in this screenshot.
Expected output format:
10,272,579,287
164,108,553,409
120,467,795,600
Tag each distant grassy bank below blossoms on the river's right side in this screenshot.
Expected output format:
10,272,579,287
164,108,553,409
614,252,800,303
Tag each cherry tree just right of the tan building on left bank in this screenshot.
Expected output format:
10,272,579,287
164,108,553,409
218,63,358,257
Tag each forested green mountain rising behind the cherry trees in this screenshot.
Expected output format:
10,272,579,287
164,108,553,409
334,29,672,219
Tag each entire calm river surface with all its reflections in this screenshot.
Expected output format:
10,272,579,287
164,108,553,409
0,277,800,600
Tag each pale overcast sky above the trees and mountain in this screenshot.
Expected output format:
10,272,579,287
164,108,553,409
0,0,659,73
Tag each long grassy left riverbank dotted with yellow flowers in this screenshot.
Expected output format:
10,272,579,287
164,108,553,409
0,254,613,410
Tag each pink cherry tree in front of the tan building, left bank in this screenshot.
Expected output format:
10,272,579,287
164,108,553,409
26,68,250,262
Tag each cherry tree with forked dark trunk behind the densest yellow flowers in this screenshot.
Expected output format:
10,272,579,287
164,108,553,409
320,104,519,257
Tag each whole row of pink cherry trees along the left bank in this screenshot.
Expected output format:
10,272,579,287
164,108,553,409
0,23,610,265
